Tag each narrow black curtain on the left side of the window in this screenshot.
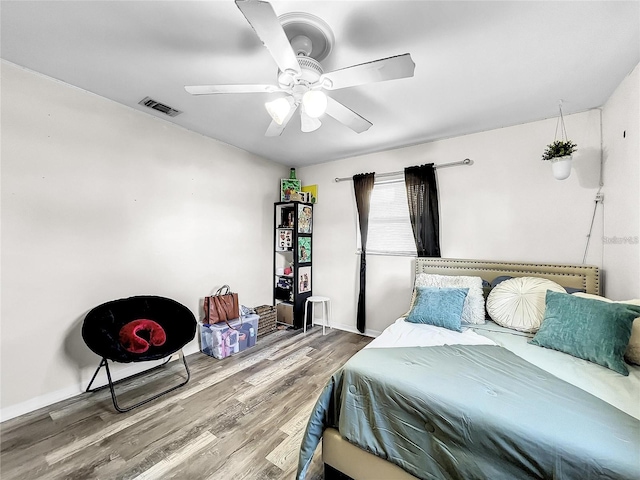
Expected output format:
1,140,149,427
353,173,375,333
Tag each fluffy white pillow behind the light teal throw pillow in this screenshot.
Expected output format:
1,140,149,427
403,273,485,324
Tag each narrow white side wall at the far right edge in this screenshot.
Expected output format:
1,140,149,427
602,62,640,300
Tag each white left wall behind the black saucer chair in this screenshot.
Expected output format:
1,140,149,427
0,62,288,419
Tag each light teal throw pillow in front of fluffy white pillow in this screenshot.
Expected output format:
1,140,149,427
406,287,469,332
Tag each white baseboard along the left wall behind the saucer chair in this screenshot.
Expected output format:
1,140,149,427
0,342,200,423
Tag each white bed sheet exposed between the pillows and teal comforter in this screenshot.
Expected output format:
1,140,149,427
365,318,640,419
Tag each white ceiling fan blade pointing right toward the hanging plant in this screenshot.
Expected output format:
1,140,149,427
320,53,416,90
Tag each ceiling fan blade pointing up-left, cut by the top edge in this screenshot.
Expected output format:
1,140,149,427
236,0,302,74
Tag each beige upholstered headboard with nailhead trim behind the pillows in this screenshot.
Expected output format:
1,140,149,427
416,257,600,295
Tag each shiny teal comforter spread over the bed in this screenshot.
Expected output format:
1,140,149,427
297,345,640,480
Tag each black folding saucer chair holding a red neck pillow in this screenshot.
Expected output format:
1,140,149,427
82,296,197,413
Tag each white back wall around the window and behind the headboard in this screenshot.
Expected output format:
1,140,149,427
299,110,613,335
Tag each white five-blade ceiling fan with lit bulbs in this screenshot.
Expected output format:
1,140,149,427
184,0,415,137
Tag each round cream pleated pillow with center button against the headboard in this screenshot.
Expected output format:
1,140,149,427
487,277,566,333
